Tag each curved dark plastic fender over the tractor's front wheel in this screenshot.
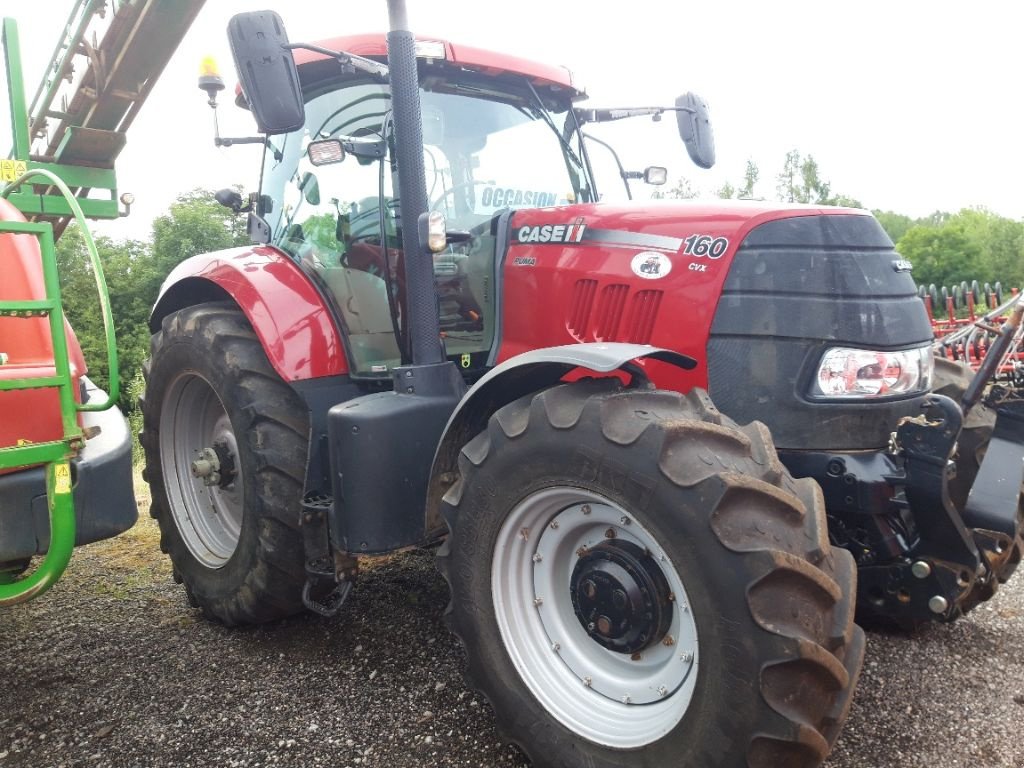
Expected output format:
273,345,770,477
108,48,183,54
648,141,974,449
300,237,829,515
424,342,697,541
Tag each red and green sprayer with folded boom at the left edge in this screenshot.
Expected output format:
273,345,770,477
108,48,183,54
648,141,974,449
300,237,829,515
0,0,202,606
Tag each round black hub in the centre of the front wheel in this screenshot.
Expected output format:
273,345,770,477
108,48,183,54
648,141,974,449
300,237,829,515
569,540,672,654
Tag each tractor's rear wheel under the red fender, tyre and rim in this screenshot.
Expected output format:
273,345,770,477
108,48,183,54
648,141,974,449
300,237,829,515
140,303,309,625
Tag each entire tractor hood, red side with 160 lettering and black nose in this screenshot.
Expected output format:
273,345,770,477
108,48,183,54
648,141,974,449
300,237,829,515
499,201,932,449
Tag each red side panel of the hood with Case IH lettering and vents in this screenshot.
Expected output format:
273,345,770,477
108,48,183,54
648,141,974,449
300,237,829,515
499,201,867,391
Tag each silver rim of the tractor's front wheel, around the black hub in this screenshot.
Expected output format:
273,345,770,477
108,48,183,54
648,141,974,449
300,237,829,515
490,487,699,749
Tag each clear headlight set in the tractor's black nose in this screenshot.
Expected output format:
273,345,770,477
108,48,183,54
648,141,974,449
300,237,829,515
811,346,935,398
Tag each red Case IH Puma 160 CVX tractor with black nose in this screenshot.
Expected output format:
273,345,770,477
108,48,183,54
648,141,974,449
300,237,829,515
130,6,1024,766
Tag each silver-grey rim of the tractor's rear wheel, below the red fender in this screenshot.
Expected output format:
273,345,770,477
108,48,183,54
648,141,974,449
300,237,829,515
160,372,244,568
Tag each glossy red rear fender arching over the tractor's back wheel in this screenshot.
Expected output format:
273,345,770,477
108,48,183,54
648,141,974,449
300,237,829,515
150,246,348,381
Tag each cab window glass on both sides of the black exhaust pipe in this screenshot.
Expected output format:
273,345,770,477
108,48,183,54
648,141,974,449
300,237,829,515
262,70,593,374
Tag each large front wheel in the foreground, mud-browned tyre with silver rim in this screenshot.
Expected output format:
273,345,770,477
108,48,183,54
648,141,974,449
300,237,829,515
438,379,864,768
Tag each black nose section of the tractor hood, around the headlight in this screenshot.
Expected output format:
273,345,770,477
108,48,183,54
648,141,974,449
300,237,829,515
708,214,933,451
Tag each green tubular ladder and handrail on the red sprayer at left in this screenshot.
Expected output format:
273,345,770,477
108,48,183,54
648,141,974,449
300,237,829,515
0,168,121,606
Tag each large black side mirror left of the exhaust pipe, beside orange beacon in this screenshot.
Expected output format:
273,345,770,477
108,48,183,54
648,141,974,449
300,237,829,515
227,10,306,136
